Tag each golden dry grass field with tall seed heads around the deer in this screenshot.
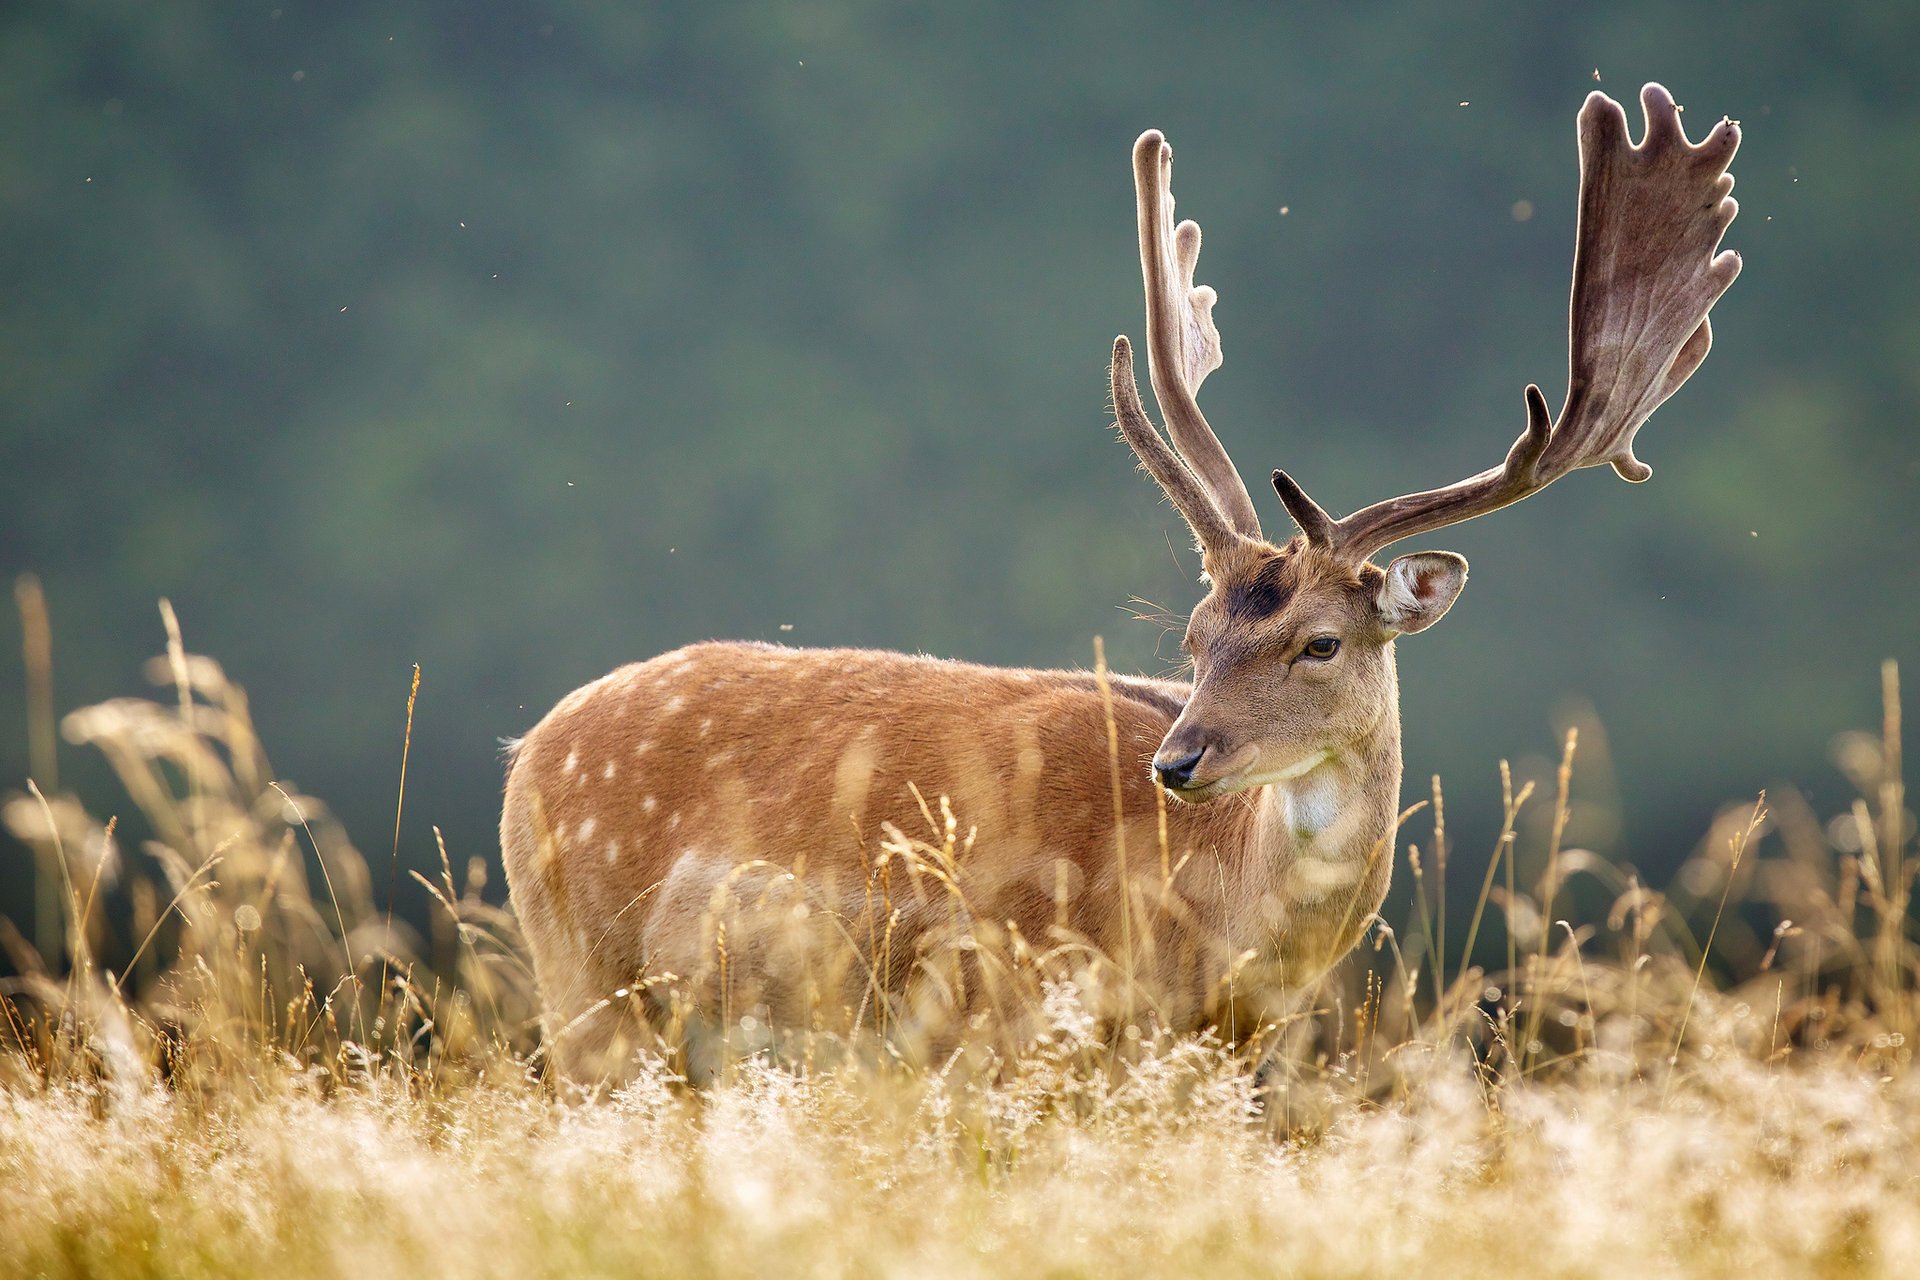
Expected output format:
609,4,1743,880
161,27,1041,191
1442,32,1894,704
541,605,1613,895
0,594,1920,1280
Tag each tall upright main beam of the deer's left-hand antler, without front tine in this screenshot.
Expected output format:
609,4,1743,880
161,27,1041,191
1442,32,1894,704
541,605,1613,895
1133,129,1260,537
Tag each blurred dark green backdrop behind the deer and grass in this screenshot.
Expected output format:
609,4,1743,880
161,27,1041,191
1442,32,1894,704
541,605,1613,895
0,0,1920,913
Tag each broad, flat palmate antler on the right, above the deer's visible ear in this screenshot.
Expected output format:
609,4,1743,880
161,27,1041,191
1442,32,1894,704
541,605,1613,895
1282,84,1740,562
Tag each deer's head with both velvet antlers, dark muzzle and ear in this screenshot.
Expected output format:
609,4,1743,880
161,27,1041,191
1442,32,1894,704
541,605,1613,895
1112,84,1740,800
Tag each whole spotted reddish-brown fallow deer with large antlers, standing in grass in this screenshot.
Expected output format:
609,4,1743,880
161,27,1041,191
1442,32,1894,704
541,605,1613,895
501,84,1740,1077
